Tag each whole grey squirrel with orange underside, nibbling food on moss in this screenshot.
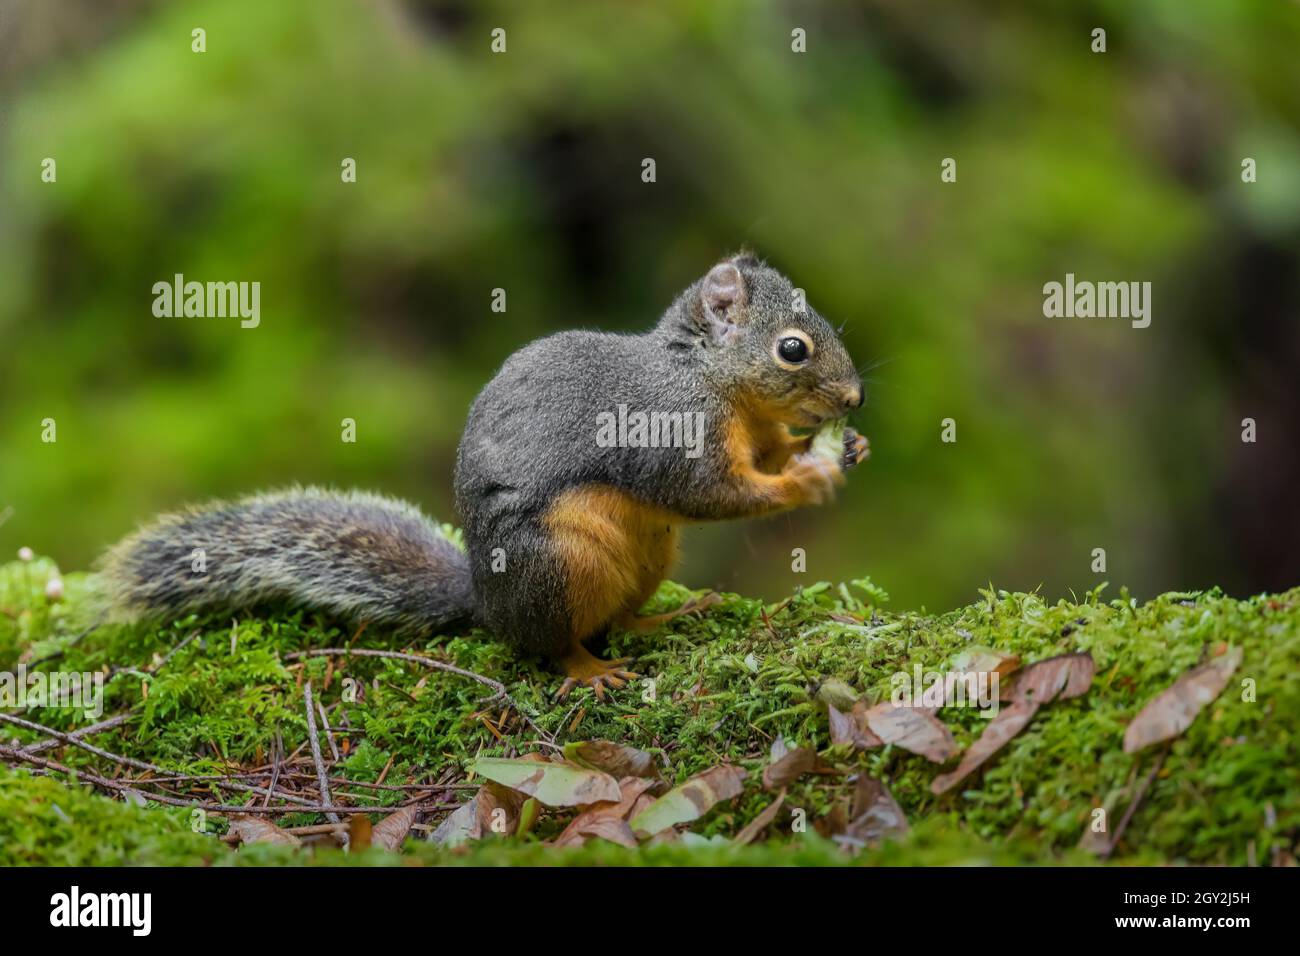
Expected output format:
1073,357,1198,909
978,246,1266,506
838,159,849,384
101,252,868,698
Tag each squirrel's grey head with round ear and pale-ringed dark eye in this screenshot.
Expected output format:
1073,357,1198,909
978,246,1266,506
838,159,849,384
666,254,865,428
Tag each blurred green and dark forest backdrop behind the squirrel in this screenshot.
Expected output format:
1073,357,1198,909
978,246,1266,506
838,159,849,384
0,0,1300,609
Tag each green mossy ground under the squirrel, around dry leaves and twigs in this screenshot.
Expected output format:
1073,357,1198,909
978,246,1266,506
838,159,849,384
0,561,1300,865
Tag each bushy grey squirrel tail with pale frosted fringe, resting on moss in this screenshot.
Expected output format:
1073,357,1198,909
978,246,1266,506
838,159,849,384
101,488,478,632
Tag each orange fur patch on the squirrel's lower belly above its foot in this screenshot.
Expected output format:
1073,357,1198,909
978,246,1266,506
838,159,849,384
543,485,681,640
